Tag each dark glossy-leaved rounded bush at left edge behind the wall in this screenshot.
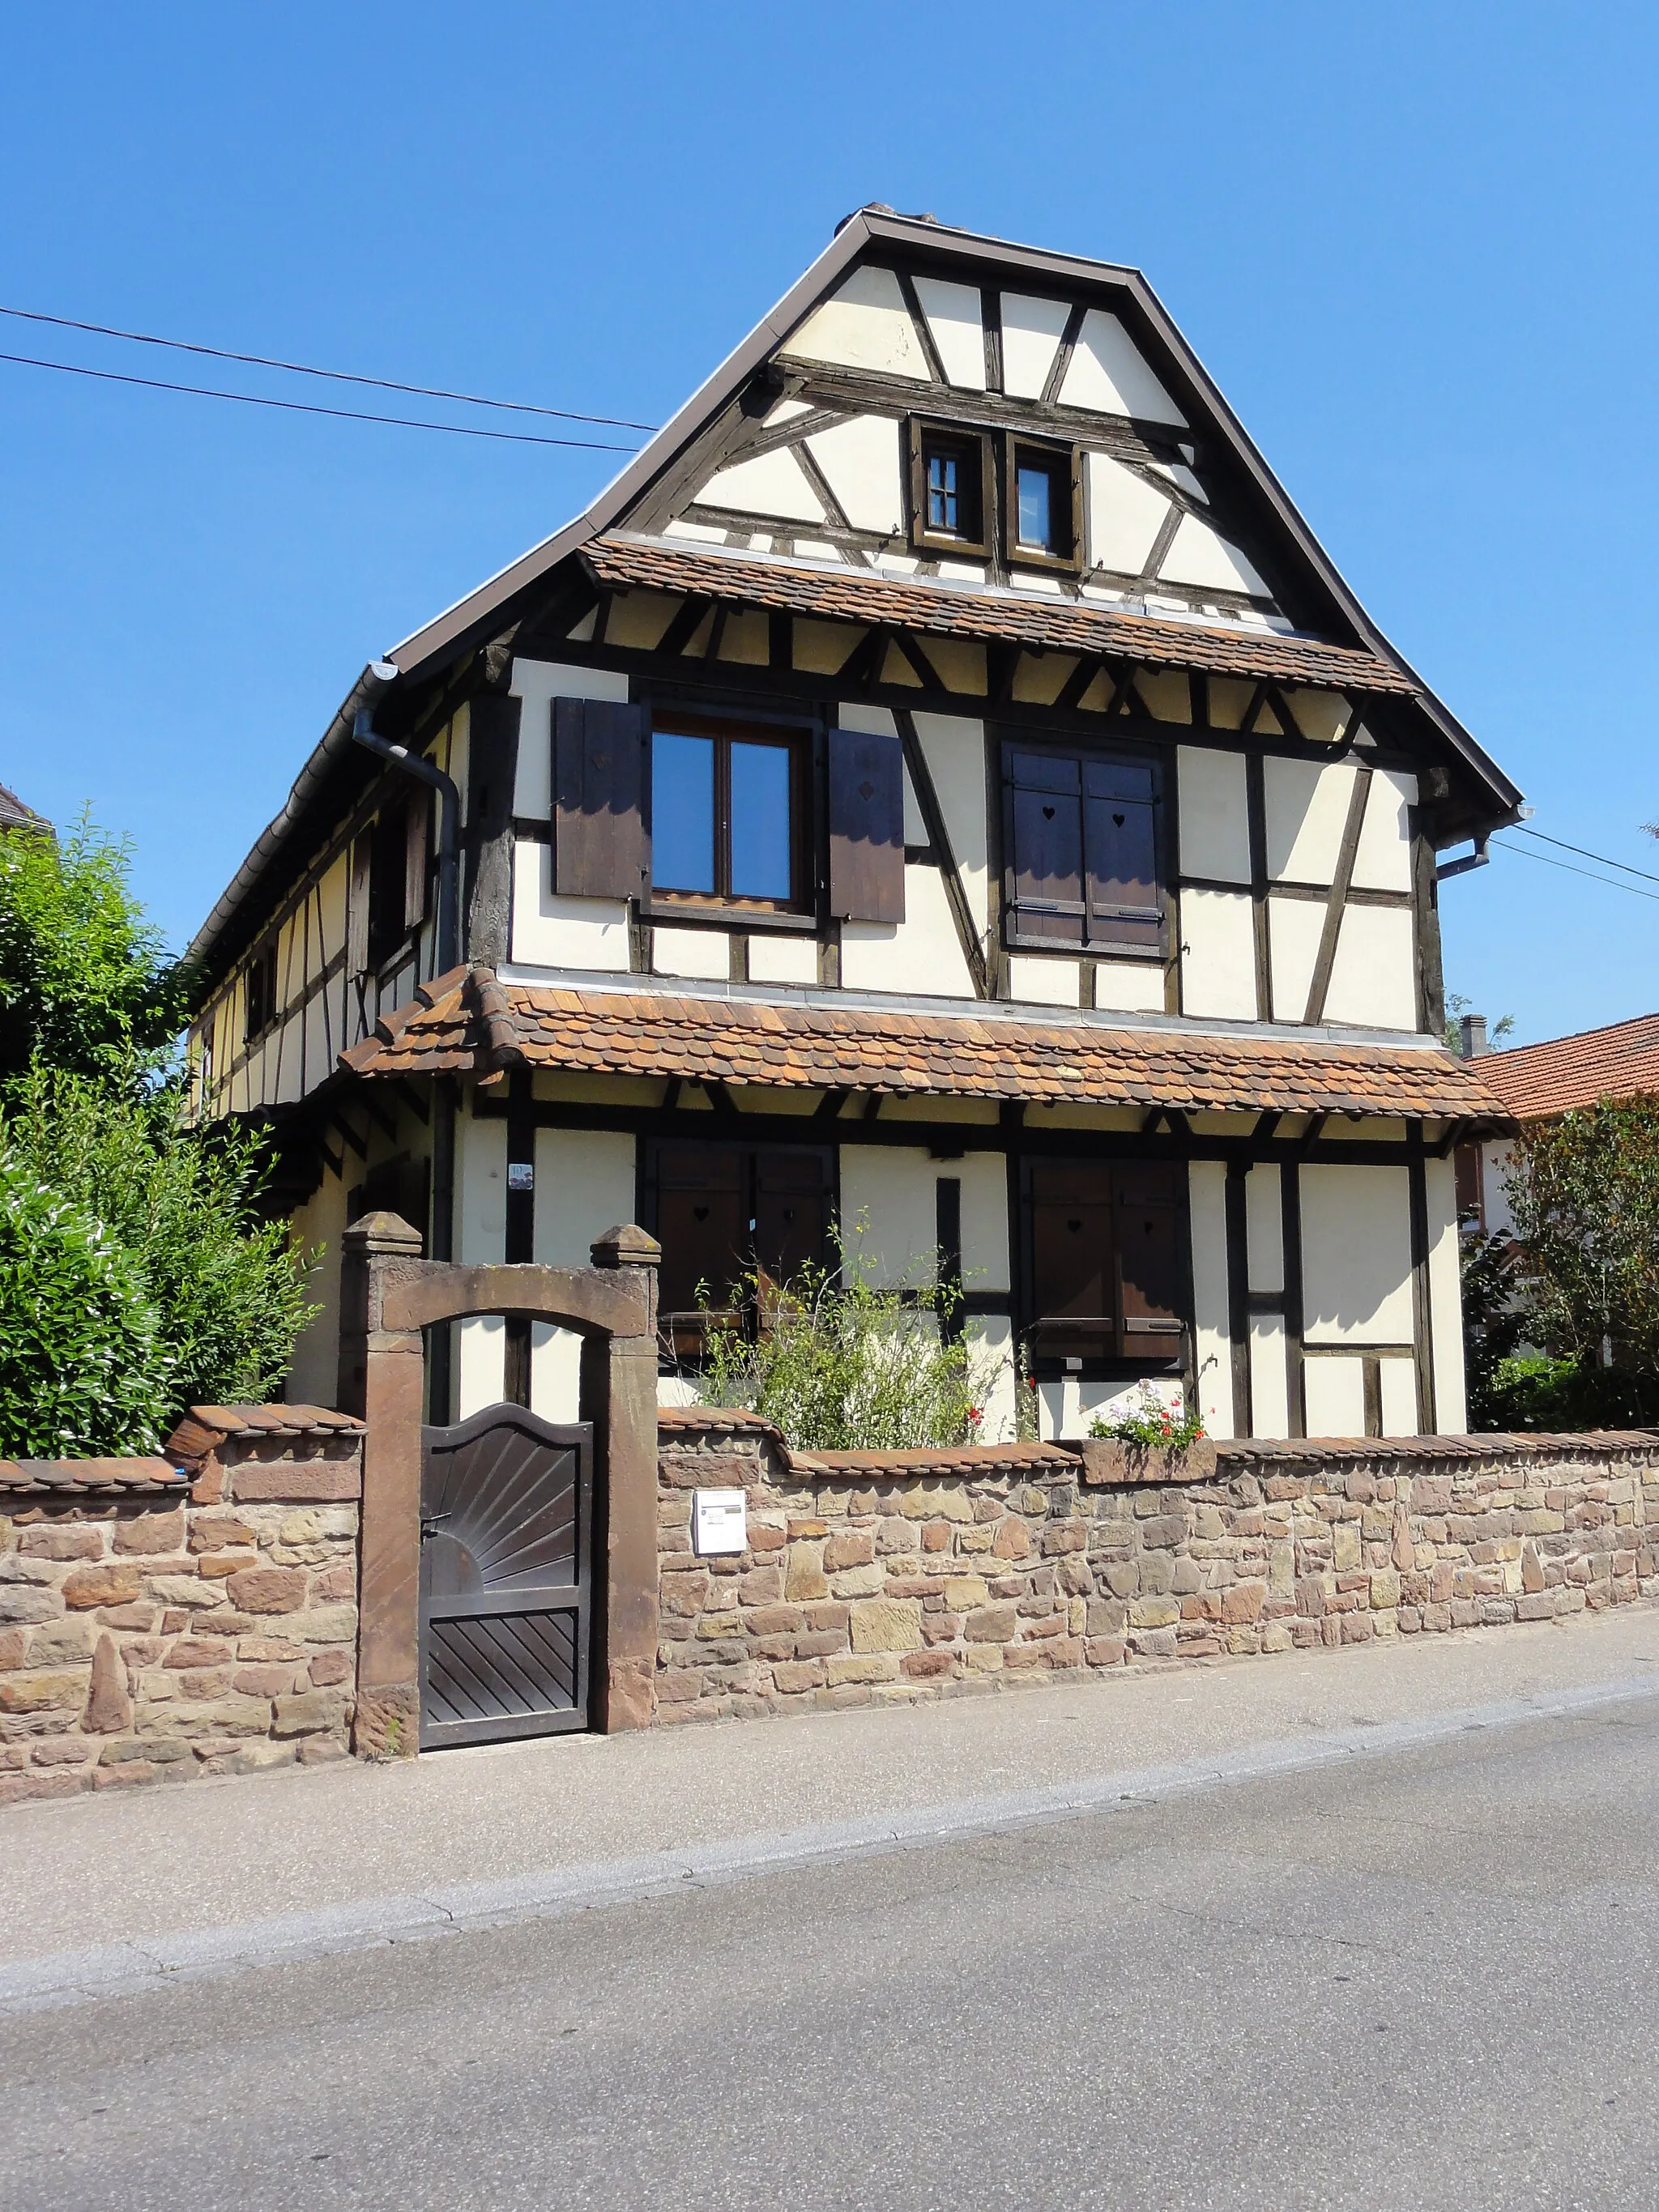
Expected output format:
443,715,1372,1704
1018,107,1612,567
0,1153,175,1460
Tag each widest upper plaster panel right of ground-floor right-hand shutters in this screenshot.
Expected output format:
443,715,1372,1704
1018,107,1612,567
1301,1161,1411,1336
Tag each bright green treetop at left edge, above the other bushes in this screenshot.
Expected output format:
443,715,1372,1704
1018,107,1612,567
0,816,188,1084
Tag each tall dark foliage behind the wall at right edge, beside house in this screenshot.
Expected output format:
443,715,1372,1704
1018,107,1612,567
1465,1097,1659,1429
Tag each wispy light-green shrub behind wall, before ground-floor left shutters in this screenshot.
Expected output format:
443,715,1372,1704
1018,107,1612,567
699,1246,996,1451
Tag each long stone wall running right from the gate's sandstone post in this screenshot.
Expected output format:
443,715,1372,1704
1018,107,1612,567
657,1407,1659,1723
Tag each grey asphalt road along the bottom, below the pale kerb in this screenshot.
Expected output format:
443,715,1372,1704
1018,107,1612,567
0,1697,1659,2212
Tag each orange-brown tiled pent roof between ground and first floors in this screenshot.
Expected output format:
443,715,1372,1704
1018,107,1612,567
341,969,1507,1126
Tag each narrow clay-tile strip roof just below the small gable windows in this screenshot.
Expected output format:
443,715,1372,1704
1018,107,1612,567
582,538,1422,697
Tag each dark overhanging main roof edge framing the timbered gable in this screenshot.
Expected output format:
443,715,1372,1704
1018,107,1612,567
188,208,1522,987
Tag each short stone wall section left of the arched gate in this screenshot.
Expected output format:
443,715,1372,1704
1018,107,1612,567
0,1404,363,1805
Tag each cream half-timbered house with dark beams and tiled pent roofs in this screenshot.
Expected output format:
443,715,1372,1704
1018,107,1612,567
179,210,1520,1435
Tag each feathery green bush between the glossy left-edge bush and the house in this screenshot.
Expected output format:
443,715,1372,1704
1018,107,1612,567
0,1068,316,1411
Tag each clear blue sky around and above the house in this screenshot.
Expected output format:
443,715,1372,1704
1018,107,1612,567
0,0,1659,1040
